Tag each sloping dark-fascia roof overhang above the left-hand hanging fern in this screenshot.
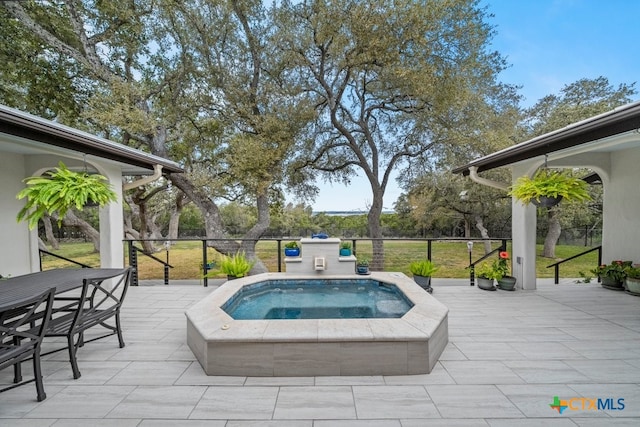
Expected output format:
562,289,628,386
0,105,184,175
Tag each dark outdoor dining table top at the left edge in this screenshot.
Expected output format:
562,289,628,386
0,268,129,312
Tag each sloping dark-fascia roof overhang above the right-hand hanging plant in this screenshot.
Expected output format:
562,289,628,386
452,102,640,175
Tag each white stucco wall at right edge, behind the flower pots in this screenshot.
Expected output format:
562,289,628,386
602,148,640,263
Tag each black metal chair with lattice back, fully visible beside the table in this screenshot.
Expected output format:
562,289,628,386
43,268,133,379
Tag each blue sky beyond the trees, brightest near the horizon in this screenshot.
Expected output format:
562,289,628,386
313,0,640,211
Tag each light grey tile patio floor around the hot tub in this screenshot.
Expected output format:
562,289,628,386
0,279,640,427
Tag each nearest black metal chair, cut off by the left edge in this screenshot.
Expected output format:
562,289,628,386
0,288,55,402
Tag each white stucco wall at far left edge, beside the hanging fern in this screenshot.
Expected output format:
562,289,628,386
0,153,32,277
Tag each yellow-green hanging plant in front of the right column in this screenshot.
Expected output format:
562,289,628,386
509,168,591,207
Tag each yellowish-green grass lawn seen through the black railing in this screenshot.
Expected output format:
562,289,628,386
42,240,598,280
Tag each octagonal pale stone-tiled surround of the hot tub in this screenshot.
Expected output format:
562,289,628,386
186,272,449,376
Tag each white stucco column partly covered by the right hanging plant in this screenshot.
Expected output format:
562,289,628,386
511,163,537,290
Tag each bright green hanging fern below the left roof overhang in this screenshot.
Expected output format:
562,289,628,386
16,162,117,230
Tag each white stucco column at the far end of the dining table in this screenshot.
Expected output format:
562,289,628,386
100,167,124,268
